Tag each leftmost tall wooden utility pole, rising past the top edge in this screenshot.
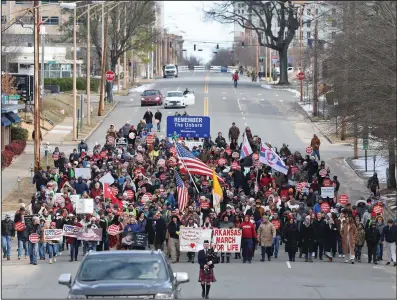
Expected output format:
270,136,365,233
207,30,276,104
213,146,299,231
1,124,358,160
34,1,41,172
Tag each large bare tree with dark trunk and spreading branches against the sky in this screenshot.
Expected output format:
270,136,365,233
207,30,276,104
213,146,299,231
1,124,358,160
205,1,299,85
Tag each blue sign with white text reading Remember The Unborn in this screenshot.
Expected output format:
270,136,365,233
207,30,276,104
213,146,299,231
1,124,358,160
167,116,210,138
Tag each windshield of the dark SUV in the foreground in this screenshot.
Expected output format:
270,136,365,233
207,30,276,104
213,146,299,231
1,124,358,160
77,256,168,282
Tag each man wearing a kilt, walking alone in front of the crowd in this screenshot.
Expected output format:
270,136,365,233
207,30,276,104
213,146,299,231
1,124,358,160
197,240,217,299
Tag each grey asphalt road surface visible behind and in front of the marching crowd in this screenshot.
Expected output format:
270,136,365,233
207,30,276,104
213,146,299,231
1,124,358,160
2,73,396,299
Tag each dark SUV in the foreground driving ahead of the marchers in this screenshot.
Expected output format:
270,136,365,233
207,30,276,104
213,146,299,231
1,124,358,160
58,250,189,299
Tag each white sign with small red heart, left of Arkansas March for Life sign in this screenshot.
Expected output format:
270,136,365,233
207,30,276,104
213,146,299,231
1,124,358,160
179,227,212,252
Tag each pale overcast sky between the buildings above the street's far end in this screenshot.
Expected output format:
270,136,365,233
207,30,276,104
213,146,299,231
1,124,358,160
164,1,234,63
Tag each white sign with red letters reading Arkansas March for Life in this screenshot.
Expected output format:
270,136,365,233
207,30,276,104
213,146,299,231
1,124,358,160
212,228,242,253
